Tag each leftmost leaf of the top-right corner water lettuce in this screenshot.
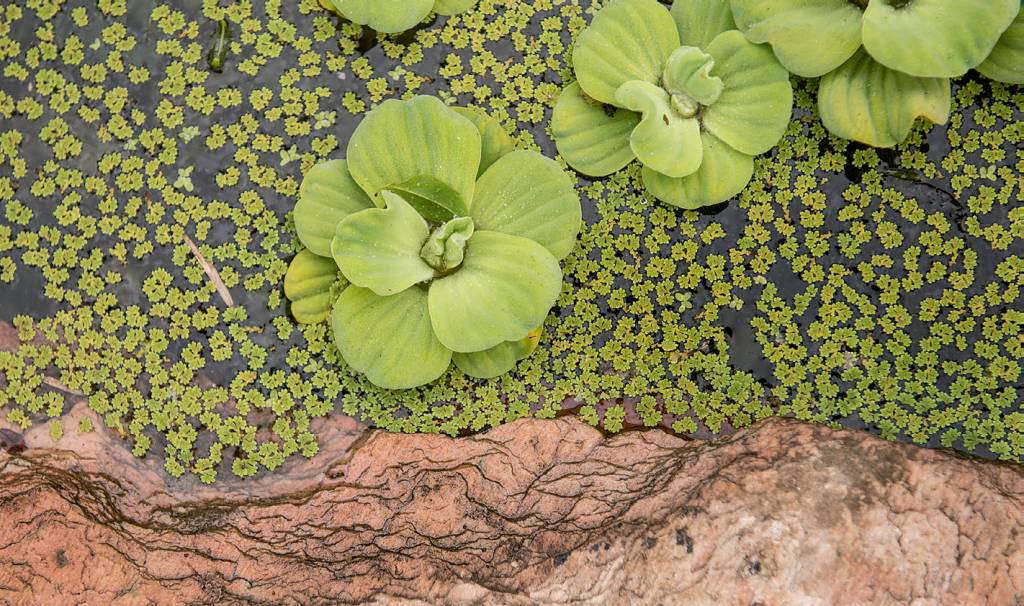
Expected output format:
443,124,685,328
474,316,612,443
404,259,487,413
731,0,863,78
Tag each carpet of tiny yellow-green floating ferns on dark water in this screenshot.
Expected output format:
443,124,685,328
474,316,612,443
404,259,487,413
0,0,1024,481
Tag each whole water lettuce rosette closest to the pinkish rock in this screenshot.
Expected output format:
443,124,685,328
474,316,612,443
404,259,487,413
285,96,582,389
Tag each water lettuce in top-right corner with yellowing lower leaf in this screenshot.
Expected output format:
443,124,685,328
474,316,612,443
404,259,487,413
730,0,1024,147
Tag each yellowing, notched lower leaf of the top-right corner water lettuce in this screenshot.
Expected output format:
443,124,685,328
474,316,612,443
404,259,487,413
818,51,951,147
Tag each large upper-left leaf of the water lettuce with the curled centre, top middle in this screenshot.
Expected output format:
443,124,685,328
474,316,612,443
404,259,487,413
572,0,679,106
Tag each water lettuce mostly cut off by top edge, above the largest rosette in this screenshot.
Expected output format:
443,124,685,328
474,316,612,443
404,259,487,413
319,0,476,34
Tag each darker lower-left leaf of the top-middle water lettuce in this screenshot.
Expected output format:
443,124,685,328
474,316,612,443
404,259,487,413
551,82,640,177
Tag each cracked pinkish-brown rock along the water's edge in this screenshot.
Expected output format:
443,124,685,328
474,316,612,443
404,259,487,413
0,408,1024,606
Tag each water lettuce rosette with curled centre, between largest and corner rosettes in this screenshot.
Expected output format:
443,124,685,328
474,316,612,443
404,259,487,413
551,0,793,209
